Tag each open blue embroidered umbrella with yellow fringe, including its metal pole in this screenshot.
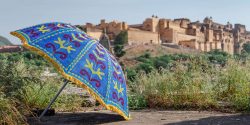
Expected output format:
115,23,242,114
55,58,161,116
11,22,129,120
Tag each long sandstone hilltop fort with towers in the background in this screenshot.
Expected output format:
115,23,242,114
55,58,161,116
81,16,250,54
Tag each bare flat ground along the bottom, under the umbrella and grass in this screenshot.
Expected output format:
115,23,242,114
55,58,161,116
28,110,250,125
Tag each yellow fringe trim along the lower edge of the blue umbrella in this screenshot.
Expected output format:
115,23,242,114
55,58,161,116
10,32,131,120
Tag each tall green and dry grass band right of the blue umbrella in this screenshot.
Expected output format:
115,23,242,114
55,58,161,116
129,59,250,111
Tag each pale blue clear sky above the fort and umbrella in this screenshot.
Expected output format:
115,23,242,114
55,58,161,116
0,0,250,44
